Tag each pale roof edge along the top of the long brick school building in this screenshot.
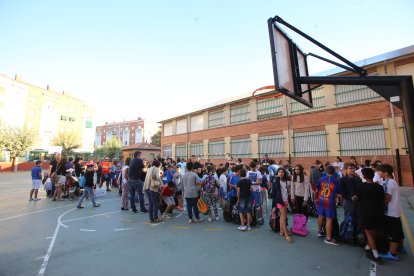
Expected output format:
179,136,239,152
158,45,414,124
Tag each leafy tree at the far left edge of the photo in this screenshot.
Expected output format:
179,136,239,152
0,127,37,171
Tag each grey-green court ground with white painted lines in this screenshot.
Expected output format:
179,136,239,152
0,172,414,276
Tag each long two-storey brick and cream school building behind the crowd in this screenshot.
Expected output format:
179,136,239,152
160,45,414,186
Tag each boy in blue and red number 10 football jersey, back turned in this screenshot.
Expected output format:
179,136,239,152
316,166,342,245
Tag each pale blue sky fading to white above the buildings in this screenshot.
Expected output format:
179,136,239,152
0,0,414,138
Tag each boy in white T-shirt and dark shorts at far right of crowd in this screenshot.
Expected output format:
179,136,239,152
378,164,407,261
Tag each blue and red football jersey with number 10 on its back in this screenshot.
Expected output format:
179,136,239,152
316,176,342,209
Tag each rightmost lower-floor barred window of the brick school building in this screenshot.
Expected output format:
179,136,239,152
339,125,387,156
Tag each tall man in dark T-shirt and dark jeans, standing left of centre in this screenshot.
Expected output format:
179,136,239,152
128,151,148,213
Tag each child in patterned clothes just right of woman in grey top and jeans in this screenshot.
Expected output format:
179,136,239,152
201,165,220,221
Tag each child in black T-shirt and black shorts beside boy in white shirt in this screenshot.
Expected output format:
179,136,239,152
356,168,385,264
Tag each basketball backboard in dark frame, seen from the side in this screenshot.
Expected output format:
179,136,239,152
267,18,313,107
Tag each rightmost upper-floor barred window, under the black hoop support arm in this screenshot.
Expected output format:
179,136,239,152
335,85,381,106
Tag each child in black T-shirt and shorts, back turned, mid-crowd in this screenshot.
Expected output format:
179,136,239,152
237,169,253,231
